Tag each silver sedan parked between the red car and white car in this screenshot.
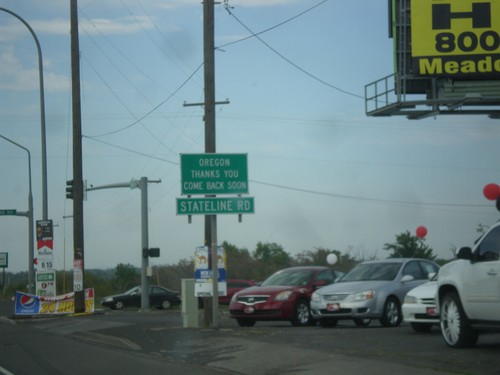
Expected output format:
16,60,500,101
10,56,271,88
311,258,439,327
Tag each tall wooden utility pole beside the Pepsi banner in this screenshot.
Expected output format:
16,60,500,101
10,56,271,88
70,0,85,313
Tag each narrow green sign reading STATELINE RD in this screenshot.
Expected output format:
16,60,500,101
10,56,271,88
177,197,254,215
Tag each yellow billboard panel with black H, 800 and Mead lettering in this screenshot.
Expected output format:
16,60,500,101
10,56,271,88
411,0,500,79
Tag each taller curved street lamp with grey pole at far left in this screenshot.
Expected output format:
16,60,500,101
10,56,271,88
0,7,48,220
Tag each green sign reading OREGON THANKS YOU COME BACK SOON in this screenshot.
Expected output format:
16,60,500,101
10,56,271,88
181,154,248,195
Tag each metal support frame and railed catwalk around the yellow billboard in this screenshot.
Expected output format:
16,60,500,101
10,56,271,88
365,0,500,119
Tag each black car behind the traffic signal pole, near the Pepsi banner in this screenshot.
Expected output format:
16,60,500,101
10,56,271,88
101,285,181,310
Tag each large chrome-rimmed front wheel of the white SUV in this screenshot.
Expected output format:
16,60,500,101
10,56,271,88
440,292,478,348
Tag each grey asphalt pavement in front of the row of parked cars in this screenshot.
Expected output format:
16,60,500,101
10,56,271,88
0,300,500,375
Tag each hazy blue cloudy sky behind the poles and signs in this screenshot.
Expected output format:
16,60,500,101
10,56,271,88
0,0,500,273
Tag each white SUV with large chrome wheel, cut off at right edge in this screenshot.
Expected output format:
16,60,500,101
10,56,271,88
437,223,500,348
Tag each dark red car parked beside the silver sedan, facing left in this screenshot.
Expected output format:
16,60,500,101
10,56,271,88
229,266,340,327
